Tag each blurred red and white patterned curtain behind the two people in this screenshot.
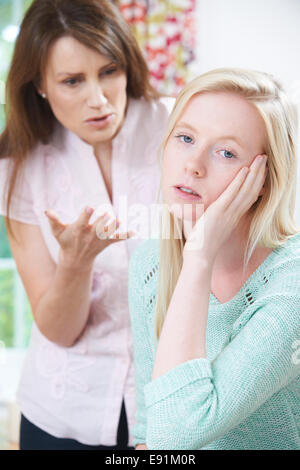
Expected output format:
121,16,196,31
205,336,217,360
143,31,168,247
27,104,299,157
115,0,196,95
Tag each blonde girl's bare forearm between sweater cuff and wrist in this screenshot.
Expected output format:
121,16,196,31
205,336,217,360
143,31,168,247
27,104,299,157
152,261,212,380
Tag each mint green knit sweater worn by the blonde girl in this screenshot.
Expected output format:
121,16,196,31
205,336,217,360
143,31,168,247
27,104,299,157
129,234,300,450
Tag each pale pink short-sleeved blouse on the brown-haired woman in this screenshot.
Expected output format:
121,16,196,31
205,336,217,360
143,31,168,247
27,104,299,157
0,98,174,446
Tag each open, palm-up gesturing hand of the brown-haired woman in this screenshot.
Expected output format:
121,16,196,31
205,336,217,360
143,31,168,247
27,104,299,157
45,207,135,269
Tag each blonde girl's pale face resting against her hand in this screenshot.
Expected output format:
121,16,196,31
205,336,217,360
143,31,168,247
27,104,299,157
162,92,266,222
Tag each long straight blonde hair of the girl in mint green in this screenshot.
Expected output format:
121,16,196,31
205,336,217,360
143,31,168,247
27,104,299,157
155,68,299,339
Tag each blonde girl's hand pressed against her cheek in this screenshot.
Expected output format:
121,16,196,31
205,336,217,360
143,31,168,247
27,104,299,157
183,155,267,266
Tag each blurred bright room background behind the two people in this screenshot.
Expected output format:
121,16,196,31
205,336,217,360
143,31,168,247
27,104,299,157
0,0,300,449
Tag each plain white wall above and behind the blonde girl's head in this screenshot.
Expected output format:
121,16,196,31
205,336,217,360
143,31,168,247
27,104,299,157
194,0,300,225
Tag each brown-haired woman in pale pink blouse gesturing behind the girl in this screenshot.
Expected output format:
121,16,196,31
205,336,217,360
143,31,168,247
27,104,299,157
0,0,173,449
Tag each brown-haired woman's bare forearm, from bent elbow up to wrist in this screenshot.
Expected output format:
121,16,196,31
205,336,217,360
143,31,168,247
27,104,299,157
34,261,93,347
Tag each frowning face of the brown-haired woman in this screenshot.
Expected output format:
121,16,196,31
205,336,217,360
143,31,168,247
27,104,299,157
40,36,127,145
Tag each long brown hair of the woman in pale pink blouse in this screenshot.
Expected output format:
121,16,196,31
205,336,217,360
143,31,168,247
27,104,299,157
0,0,160,235
